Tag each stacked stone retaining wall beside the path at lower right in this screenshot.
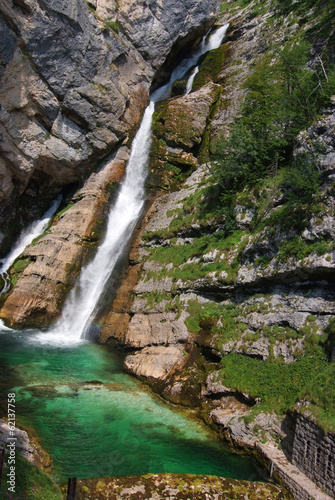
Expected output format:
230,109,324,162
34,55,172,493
292,415,335,497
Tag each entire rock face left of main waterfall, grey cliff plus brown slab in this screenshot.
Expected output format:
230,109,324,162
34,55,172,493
0,0,218,325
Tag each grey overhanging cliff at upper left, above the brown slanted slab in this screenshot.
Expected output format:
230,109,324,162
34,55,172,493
0,0,218,249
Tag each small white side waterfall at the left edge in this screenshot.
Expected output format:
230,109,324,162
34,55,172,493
0,195,62,295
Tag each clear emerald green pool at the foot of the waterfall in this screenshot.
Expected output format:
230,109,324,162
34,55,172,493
0,332,264,481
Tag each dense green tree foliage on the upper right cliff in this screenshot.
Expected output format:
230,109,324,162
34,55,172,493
213,41,335,200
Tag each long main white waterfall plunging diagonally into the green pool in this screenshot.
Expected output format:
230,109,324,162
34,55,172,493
38,25,228,344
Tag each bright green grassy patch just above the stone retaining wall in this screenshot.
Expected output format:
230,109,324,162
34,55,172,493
220,346,335,431
